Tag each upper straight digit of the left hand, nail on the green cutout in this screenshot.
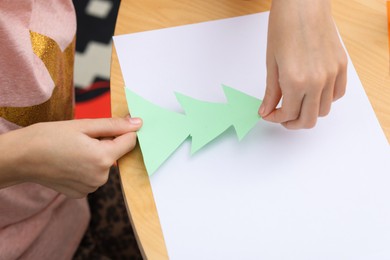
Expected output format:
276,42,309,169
76,117,142,138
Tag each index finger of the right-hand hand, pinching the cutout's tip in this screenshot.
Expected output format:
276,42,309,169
264,92,304,123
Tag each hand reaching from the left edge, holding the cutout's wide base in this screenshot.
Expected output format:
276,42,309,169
0,118,142,198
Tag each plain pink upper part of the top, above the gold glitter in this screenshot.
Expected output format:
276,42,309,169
0,0,76,107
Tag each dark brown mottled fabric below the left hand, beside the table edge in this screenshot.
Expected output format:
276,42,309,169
74,166,142,260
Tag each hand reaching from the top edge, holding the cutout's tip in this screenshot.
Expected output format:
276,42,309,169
259,0,347,129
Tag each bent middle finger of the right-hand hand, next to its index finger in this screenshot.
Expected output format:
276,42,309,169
283,92,321,129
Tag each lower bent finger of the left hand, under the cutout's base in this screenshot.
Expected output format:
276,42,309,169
101,132,137,161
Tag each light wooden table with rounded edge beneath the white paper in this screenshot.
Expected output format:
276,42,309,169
111,0,390,259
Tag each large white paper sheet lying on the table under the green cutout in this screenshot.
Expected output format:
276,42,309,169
114,13,390,260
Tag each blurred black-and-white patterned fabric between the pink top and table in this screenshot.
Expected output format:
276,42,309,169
73,0,120,102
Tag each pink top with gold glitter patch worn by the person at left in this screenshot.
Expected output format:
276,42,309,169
0,0,89,260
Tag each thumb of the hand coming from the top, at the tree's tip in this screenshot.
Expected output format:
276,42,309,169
259,62,282,117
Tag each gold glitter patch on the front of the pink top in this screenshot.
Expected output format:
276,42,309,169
0,31,76,126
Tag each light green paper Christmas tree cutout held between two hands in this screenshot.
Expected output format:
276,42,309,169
125,85,262,175
